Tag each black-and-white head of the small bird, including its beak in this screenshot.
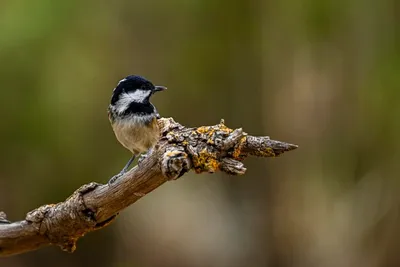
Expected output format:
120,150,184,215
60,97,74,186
111,75,167,106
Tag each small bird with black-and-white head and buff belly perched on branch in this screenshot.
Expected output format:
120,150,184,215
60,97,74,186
108,75,167,185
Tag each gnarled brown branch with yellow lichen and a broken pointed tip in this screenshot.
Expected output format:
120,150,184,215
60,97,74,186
0,118,297,256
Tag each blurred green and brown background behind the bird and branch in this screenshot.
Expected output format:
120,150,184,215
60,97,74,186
0,0,400,267
